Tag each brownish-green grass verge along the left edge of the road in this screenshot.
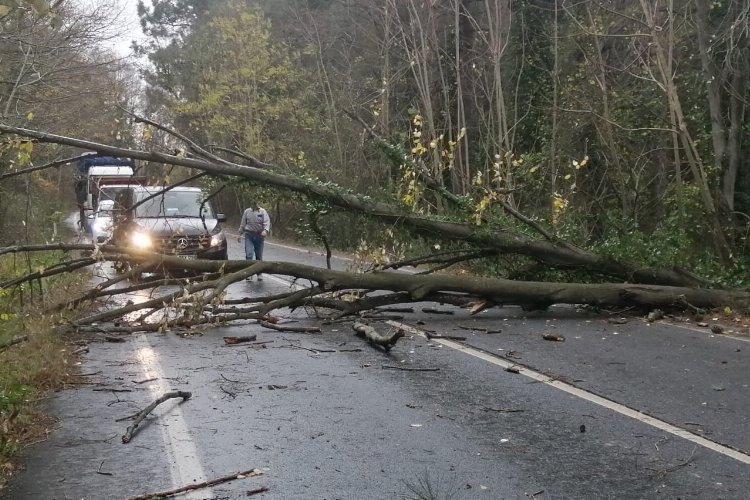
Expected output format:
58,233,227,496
0,253,87,497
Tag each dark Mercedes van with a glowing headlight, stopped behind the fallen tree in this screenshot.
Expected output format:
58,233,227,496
112,186,227,260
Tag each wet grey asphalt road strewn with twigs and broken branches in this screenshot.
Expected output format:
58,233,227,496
8,236,750,500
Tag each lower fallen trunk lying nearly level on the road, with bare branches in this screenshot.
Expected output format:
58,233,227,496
2,246,750,332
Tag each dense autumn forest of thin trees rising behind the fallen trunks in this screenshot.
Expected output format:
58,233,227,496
0,0,750,286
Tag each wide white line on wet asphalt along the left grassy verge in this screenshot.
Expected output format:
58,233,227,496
135,335,214,500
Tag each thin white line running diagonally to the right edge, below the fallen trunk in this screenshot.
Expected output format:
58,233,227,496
388,321,750,464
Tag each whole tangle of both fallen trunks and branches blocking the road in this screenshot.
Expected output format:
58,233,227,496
0,120,750,331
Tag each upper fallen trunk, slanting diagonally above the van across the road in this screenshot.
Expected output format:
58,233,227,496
0,122,710,287
